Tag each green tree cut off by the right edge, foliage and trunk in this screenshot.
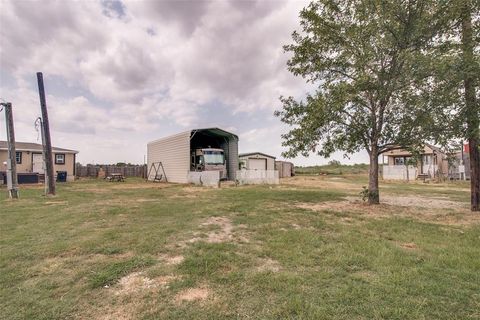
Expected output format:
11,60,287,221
423,0,480,211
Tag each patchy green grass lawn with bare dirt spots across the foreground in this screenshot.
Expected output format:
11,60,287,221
0,175,480,319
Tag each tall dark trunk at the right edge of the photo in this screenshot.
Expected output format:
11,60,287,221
462,0,480,211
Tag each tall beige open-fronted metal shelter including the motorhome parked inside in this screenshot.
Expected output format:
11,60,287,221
147,128,238,186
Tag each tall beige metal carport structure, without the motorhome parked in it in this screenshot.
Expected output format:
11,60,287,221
147,128,238,183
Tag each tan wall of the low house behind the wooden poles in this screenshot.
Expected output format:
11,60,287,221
0,150,75,181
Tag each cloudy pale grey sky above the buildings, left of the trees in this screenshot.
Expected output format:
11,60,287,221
0,0,368,165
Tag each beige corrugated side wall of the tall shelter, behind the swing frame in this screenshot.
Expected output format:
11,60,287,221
147,131,190,183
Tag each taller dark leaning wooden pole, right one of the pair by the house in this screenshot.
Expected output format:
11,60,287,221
37,72,55,195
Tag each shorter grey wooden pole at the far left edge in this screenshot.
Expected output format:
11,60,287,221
1,102,18,199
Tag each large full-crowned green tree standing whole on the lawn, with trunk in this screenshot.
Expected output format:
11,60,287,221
275,0,440,204
